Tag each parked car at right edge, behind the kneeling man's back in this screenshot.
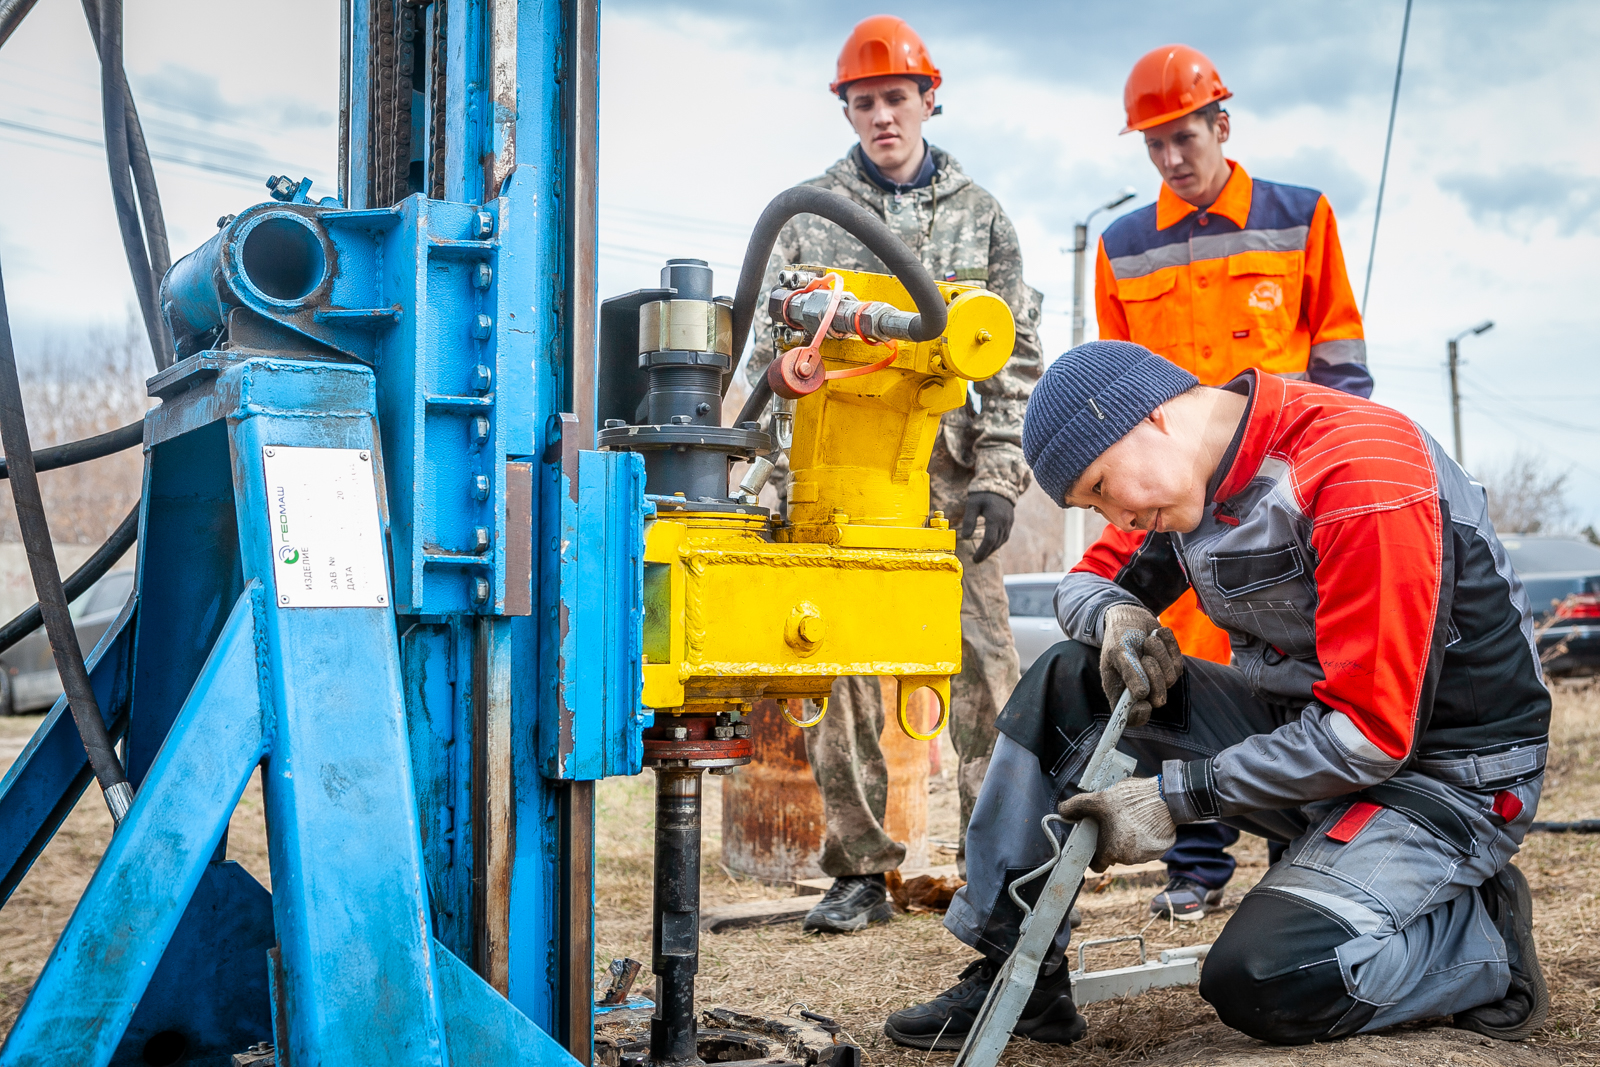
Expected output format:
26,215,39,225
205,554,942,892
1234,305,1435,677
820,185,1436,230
1501,534,1600,677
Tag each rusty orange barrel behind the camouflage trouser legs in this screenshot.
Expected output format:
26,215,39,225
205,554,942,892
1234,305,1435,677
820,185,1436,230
722,678,936,885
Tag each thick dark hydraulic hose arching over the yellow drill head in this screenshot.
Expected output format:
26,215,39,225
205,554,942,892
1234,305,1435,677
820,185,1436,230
733,186,946,426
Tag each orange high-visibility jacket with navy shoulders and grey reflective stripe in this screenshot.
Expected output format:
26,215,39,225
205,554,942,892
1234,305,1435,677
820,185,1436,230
1094,160,1373,397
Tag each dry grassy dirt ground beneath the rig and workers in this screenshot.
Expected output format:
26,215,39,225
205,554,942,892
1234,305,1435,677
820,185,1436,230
0,683,1600,1067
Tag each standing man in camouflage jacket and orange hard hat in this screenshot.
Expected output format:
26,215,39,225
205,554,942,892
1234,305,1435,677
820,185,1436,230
747,16,1042,933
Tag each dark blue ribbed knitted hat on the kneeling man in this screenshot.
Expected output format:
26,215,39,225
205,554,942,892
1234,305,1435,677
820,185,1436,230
1022,341,1200,506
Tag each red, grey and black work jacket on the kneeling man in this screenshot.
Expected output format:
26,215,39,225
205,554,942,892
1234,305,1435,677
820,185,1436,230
1056,371,1550,822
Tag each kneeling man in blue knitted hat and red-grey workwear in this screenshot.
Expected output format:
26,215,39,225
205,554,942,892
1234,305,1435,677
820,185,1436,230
885,341,1550,1048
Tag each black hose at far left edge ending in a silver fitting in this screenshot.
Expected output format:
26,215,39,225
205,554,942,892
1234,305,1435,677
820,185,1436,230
0,259,133,824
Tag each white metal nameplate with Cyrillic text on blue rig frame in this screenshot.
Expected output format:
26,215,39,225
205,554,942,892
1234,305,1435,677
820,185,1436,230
261,445,389,608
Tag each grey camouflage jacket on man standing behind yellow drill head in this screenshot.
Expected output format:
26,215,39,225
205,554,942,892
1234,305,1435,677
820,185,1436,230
746,146,1043,501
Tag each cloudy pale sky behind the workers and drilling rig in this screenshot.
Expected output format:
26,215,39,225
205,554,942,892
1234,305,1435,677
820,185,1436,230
0,0,1600,522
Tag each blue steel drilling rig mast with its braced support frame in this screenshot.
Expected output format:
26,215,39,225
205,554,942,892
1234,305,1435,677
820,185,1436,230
0,0,646,1067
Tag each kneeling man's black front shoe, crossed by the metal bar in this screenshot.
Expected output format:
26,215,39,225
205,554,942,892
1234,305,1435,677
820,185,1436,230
883,960,1090,1053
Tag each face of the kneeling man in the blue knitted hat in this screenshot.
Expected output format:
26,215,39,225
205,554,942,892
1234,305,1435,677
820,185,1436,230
1066,405,1205,533
